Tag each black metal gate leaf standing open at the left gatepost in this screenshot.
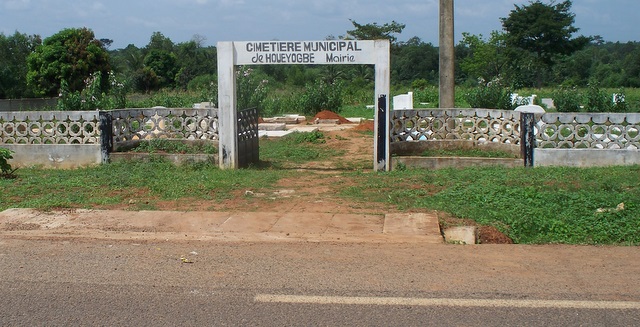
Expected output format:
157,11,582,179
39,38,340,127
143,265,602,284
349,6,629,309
238,108,260,168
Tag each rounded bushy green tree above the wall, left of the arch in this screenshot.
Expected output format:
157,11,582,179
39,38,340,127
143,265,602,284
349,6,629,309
27,28,111,96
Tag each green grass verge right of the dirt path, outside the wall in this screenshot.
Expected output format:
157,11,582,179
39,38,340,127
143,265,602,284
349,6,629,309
343,166,640,245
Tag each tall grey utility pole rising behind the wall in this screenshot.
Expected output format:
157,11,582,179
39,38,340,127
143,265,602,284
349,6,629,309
439,0,456,108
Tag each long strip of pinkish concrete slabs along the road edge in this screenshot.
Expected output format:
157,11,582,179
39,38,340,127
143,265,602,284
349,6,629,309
0,209,442,244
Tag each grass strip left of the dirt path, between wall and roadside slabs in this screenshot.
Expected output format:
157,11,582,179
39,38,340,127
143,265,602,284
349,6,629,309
0,160,282,211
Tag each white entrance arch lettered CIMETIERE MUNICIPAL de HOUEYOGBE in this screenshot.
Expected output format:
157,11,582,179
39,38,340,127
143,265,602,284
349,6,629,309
217,40,391,170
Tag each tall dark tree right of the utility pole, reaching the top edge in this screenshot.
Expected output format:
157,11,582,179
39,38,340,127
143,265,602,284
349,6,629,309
501,0,589,86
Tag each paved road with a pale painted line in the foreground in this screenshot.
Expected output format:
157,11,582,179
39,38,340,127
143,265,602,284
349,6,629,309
0,235,640,326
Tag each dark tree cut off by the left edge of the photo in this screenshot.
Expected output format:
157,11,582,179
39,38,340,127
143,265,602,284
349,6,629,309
0,31,42,99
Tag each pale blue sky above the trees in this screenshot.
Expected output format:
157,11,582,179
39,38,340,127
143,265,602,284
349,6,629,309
0,0,640,50
